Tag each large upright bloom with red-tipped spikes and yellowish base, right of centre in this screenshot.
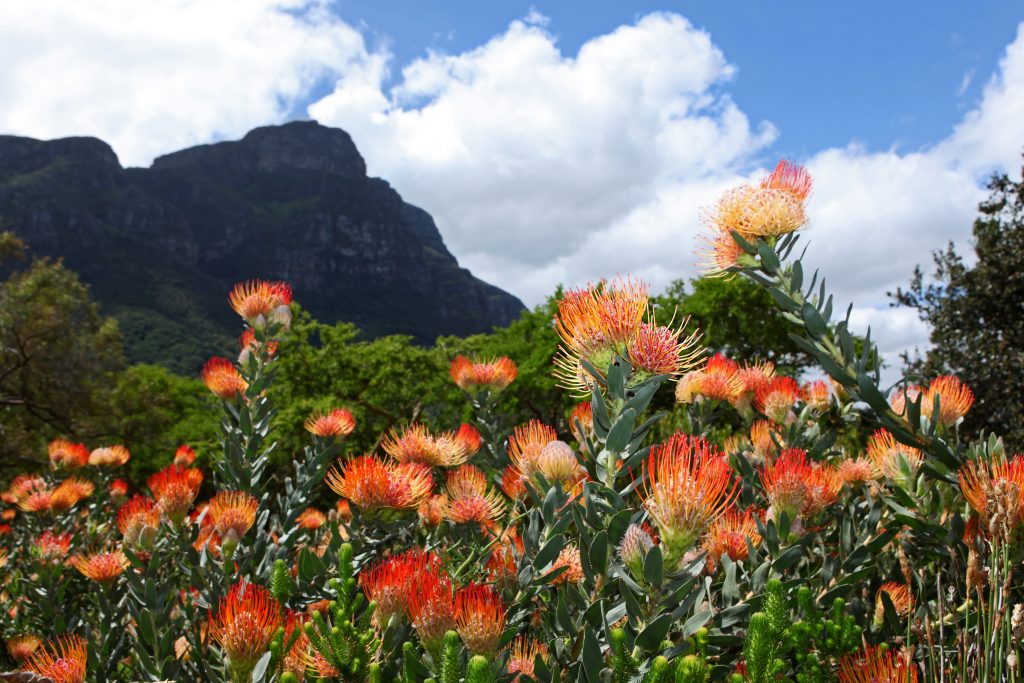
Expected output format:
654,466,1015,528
641,432,739,568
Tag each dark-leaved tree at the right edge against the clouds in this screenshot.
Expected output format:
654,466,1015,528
890,167,1024,451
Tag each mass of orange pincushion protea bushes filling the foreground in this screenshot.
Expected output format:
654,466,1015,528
0,162,1024,683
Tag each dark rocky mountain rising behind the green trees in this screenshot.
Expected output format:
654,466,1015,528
0,121,523,372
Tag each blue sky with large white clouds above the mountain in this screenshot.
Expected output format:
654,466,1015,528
0,0,1024,374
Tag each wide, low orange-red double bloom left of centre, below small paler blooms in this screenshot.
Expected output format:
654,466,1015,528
326,456,433,512
